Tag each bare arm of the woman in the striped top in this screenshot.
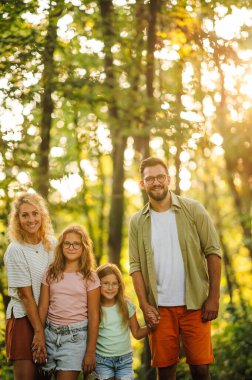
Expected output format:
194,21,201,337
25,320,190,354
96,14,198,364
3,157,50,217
18,286,47,362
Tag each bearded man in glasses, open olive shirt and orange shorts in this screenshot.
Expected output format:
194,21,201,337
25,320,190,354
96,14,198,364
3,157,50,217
129,157,221,380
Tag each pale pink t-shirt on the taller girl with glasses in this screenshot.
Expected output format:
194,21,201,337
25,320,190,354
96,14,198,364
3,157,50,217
42,272,100,325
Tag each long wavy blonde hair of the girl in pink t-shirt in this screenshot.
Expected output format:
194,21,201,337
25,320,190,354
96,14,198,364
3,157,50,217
47,226,95,282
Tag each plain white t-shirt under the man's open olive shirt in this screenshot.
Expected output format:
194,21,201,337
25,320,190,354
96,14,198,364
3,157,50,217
150,209,185,306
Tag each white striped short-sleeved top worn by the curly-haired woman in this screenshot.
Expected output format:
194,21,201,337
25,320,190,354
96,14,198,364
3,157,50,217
4,237,57,319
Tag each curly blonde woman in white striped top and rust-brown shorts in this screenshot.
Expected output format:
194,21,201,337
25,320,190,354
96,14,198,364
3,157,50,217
4,192,56,380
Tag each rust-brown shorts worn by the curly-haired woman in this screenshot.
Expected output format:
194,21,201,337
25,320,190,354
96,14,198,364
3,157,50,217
5,317,34,362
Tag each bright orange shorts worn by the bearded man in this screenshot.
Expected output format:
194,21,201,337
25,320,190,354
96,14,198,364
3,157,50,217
149,306,214,367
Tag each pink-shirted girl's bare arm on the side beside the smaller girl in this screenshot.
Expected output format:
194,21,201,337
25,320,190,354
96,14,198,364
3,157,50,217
82,288,100,373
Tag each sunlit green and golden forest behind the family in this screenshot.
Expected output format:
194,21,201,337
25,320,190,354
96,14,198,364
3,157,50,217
0,0,252,380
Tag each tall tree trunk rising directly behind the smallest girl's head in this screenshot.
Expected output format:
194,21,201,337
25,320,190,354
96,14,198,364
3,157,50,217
99,0,126,267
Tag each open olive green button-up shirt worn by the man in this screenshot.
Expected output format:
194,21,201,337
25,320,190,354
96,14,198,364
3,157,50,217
129,192,221,310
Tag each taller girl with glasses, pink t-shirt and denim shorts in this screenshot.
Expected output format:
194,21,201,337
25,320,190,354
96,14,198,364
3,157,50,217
39,226,100,380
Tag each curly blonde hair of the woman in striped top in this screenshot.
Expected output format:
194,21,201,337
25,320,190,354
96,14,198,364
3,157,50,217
8,192,53,251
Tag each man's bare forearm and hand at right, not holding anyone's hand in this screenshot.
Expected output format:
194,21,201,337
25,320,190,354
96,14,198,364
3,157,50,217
202,255,221,322
